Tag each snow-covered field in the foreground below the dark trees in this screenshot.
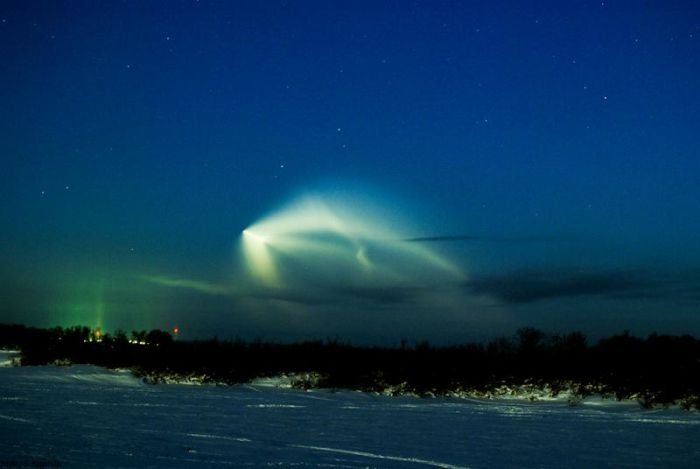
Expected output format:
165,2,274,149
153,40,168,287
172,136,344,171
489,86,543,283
0,353,700,468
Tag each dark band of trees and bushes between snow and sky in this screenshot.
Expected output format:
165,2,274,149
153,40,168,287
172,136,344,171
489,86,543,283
0,325,700,410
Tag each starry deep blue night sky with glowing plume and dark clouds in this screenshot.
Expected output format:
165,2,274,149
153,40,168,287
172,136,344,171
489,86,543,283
0,0,700,344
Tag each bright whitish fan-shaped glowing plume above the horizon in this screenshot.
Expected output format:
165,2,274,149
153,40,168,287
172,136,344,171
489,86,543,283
241,189,464,291
